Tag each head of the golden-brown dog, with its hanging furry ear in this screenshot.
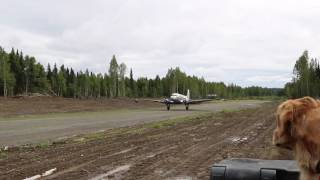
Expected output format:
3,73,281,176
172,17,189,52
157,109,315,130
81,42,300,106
273,97,319,149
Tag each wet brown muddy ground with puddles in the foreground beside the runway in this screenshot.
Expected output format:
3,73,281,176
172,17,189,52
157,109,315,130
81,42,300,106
0,103,292,180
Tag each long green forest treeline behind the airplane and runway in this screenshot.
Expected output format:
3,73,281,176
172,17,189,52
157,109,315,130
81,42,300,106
0,47,279,98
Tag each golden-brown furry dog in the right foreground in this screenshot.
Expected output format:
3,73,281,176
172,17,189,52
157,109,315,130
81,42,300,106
273,97,320,180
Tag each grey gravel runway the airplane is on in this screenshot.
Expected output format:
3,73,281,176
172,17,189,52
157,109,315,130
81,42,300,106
0,100,263,147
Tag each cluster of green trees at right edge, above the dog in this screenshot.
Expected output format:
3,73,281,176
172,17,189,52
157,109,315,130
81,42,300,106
285,51,320,98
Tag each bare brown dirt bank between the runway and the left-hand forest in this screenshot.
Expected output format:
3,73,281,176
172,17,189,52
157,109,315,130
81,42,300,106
0,95,159,117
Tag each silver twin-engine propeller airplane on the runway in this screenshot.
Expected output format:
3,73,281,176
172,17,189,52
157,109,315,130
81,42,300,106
153,89,212,111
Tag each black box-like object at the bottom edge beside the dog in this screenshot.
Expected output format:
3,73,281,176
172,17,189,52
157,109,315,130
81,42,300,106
210,159,299,180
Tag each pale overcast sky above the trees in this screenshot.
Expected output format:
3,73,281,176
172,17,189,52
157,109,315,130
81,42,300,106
0,0,320,87
